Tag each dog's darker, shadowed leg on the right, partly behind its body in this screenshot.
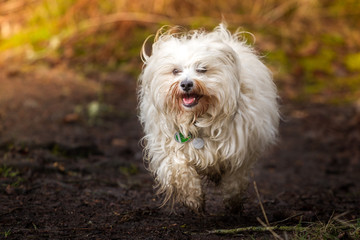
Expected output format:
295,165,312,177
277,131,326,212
221,169,248,213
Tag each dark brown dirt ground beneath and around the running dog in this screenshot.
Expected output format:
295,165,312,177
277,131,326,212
0,62,360,239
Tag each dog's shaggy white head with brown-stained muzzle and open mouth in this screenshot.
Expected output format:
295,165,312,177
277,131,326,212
140,25,240,124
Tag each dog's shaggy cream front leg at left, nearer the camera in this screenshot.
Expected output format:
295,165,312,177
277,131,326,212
157,157,204,213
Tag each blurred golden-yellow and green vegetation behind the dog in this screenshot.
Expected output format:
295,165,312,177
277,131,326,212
0,0,360,104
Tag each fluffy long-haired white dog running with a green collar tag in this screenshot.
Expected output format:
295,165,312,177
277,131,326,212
138,24,279,212
